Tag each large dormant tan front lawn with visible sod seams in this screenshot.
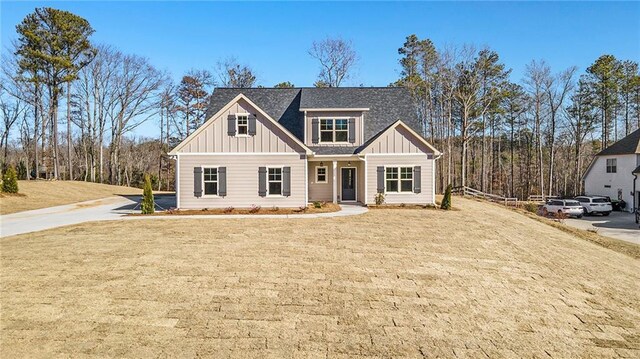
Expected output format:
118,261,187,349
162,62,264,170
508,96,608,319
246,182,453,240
0,198,640,358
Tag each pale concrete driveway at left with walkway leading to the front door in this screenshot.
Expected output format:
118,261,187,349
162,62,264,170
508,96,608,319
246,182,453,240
0,196,368,237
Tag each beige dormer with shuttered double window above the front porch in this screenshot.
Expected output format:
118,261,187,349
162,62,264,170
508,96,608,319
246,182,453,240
300,108,369,147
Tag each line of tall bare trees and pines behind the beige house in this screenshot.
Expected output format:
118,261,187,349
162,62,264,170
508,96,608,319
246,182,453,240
0,8,640,198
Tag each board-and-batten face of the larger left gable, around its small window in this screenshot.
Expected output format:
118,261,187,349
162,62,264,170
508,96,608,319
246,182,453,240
169,95,307,155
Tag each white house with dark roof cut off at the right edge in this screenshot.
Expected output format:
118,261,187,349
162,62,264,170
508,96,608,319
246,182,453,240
582,129,640,211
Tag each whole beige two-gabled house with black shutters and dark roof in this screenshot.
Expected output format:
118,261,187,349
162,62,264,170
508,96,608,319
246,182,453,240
169,87,441,208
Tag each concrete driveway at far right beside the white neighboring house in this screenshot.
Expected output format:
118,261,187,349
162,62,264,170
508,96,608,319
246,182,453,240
565,212,640,244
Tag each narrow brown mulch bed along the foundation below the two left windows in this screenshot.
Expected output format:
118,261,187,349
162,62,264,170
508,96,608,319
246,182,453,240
130,203,340,216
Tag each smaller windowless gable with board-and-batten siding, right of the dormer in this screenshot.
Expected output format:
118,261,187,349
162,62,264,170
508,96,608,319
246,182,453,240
359,121,440,155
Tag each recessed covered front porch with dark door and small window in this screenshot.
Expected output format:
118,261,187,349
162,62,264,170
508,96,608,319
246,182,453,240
307,155,366,204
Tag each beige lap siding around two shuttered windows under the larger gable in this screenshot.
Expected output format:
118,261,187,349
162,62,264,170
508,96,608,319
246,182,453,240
178,154,306,209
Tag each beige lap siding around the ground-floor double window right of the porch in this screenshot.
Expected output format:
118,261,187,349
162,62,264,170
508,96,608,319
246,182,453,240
367,154,435,204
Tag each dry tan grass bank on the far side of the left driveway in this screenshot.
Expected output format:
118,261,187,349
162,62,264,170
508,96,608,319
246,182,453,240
0,181,142,214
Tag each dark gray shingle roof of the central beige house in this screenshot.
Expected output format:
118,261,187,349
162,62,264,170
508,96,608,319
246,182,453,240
207,87,422,154
